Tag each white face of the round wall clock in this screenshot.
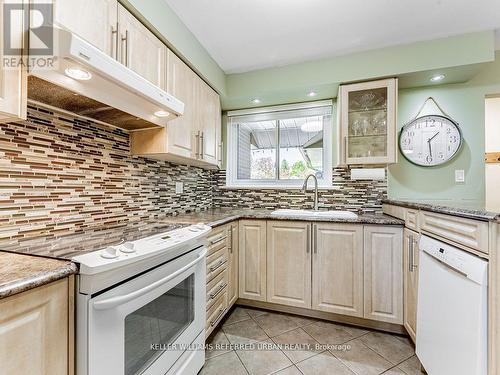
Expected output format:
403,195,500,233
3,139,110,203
399,115,462,167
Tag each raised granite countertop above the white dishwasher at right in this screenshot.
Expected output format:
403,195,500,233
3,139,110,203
383,199,500,221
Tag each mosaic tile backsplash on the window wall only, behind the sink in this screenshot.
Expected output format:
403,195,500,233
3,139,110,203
213,168,387,214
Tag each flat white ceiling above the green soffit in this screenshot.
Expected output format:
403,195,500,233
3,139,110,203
165,0,500,73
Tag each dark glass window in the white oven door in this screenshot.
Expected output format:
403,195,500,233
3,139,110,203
125,274,194,375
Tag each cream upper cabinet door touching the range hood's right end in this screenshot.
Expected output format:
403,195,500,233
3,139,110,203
167,50,199,158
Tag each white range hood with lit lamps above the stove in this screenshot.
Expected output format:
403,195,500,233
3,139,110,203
28,28,184,130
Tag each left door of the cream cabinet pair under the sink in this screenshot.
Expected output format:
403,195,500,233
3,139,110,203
267,221,311,309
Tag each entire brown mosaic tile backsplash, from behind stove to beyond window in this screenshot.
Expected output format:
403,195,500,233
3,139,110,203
0,106,387,239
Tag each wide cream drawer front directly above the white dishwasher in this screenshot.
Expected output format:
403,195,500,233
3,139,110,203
420,211,488,254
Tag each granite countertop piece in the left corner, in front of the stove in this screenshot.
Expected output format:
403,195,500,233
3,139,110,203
0,252,77,299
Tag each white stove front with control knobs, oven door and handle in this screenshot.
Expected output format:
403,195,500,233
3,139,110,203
72,224,211,375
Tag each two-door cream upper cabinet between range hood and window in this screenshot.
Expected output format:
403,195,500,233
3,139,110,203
131,51,222,168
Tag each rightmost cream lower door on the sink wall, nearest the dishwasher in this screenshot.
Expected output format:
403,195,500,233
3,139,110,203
364,225,403,324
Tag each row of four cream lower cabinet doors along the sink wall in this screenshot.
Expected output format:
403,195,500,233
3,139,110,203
239,220,403,325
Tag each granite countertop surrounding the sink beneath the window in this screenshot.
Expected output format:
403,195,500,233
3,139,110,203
165,208,404,227
